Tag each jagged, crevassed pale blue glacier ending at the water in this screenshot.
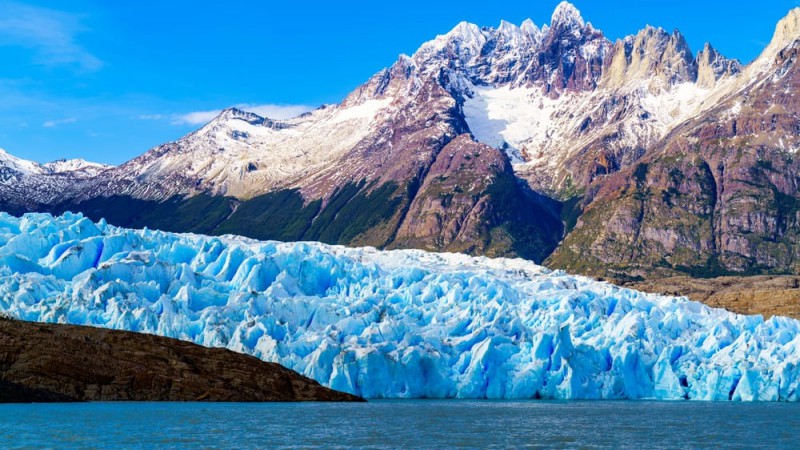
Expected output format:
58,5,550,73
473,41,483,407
0,213,800,401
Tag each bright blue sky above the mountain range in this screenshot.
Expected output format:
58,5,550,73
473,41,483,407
0,0,800,164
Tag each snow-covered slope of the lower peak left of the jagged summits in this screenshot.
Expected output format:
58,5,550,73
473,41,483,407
98,99,390,200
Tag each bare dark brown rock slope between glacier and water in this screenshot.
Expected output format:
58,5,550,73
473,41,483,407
0,319,361,402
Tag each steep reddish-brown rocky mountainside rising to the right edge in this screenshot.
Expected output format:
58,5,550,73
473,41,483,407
550,8,800,277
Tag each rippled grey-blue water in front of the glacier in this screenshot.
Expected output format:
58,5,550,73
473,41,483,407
0,400,800,449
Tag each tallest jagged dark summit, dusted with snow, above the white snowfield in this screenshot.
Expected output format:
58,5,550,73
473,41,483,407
412,2,612,96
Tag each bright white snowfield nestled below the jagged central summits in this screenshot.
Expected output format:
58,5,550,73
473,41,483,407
463,80,713,167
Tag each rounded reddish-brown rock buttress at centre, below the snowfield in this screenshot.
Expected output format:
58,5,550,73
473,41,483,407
392,135,562,259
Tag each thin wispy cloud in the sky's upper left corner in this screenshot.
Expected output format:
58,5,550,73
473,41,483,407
0,0,103,71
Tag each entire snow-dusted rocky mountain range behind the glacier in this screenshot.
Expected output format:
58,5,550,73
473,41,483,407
0,2,800,280
